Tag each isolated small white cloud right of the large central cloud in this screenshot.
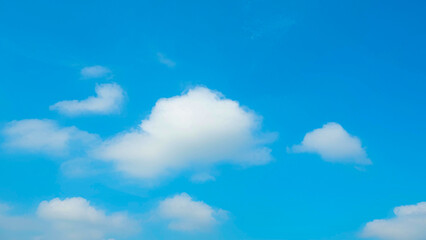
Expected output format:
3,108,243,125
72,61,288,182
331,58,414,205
291,123,371,164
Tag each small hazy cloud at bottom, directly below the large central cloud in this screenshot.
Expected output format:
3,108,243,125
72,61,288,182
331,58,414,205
157,193,227,231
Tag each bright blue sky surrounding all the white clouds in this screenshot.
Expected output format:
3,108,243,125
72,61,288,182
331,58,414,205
0,0,426,240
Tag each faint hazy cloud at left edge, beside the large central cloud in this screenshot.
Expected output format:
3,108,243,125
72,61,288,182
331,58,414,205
3,119,97,154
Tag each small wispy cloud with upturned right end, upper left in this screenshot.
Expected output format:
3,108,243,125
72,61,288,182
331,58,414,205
50,83,124,116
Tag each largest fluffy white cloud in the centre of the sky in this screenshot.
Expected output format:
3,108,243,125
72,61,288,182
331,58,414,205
95,87,271,178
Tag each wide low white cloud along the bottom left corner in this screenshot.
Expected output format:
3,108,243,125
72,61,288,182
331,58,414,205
0,197,139,240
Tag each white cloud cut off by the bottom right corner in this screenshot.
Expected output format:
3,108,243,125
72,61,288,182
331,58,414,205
362,202,426,240
